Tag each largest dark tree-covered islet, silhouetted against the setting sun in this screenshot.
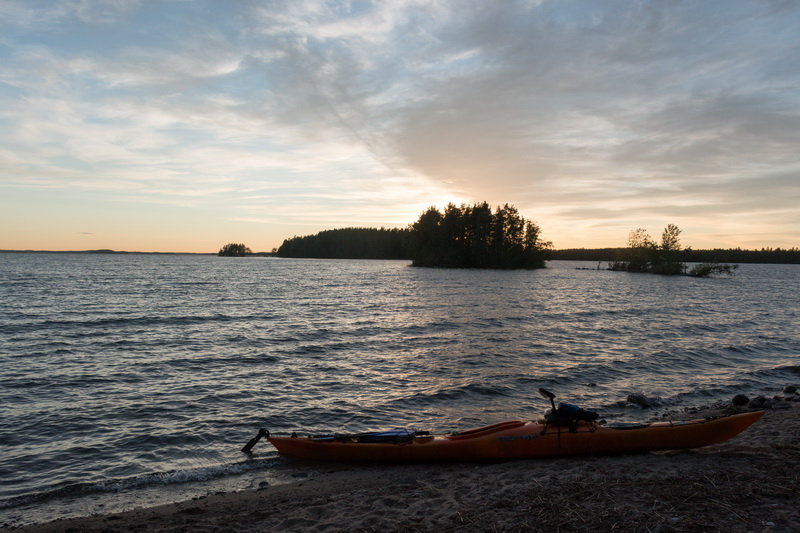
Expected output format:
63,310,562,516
411,202,552,269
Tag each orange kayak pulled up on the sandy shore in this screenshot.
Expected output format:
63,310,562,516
265,411,764,462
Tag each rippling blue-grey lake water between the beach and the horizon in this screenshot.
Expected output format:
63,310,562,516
0,253,800,526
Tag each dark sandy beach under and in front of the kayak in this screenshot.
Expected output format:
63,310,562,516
4,402,800,533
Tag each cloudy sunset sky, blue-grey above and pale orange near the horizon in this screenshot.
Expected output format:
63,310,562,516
0,0,800,253
